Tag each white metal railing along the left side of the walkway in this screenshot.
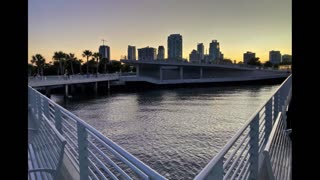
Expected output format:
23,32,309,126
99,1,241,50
28,86,165,180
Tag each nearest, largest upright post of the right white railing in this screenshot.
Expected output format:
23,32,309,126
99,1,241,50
249,114,259,179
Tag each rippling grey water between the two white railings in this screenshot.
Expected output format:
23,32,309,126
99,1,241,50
52,85,279,179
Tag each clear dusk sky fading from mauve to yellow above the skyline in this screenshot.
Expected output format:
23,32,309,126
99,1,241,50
28,0,292,63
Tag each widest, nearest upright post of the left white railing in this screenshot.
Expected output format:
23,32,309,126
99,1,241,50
77,121,89,180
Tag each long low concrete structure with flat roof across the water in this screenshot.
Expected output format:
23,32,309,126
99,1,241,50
120,60,290,84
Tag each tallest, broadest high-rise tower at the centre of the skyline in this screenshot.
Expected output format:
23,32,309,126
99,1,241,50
168,34,182,60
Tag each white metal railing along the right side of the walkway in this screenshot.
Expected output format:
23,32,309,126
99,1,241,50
195,75,292,180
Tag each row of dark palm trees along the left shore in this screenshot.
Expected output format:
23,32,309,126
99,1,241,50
31,50,109,75
